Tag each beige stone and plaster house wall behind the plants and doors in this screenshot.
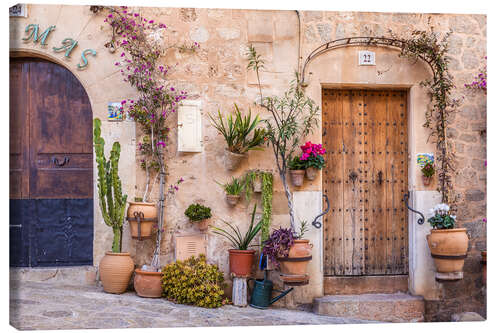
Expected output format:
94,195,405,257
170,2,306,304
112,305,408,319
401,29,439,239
10,5,486,320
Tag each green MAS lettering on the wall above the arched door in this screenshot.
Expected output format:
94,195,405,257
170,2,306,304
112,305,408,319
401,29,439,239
22,23,97,70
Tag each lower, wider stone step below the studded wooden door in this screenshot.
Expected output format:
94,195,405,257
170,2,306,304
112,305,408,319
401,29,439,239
313,293,425,323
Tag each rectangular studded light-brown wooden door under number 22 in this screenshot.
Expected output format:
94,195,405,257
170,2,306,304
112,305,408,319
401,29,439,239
322,89,408,276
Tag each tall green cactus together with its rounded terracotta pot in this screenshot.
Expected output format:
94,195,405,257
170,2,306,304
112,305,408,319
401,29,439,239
94,118,134,294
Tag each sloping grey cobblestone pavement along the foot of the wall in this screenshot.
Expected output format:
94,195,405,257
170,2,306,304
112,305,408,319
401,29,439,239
10,281,376,330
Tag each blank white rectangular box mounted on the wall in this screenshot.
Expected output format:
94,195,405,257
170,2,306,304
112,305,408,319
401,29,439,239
177,100,202,152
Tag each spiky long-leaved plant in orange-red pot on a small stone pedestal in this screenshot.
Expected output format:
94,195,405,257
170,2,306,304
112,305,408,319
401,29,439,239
211,205,262,277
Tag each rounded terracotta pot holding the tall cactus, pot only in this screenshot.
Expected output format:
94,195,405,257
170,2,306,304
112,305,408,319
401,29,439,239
99,252,134,294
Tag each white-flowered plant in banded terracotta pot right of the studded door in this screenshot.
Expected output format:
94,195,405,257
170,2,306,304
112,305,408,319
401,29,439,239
427,203,469,276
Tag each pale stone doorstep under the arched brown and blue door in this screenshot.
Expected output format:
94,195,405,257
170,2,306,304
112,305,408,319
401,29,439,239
9,266,98,285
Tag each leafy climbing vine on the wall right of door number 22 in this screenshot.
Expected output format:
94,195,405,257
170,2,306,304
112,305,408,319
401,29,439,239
391,26,460,205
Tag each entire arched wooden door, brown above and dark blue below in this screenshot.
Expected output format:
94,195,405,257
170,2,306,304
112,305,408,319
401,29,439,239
10,58,94,267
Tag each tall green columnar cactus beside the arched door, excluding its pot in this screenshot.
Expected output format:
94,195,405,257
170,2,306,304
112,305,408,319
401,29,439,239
94,118,127,253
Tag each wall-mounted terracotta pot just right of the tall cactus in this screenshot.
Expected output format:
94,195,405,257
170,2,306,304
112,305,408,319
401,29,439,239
127,202,158,240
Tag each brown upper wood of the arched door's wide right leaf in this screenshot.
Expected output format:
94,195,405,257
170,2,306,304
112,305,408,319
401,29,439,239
30,61,93,199
